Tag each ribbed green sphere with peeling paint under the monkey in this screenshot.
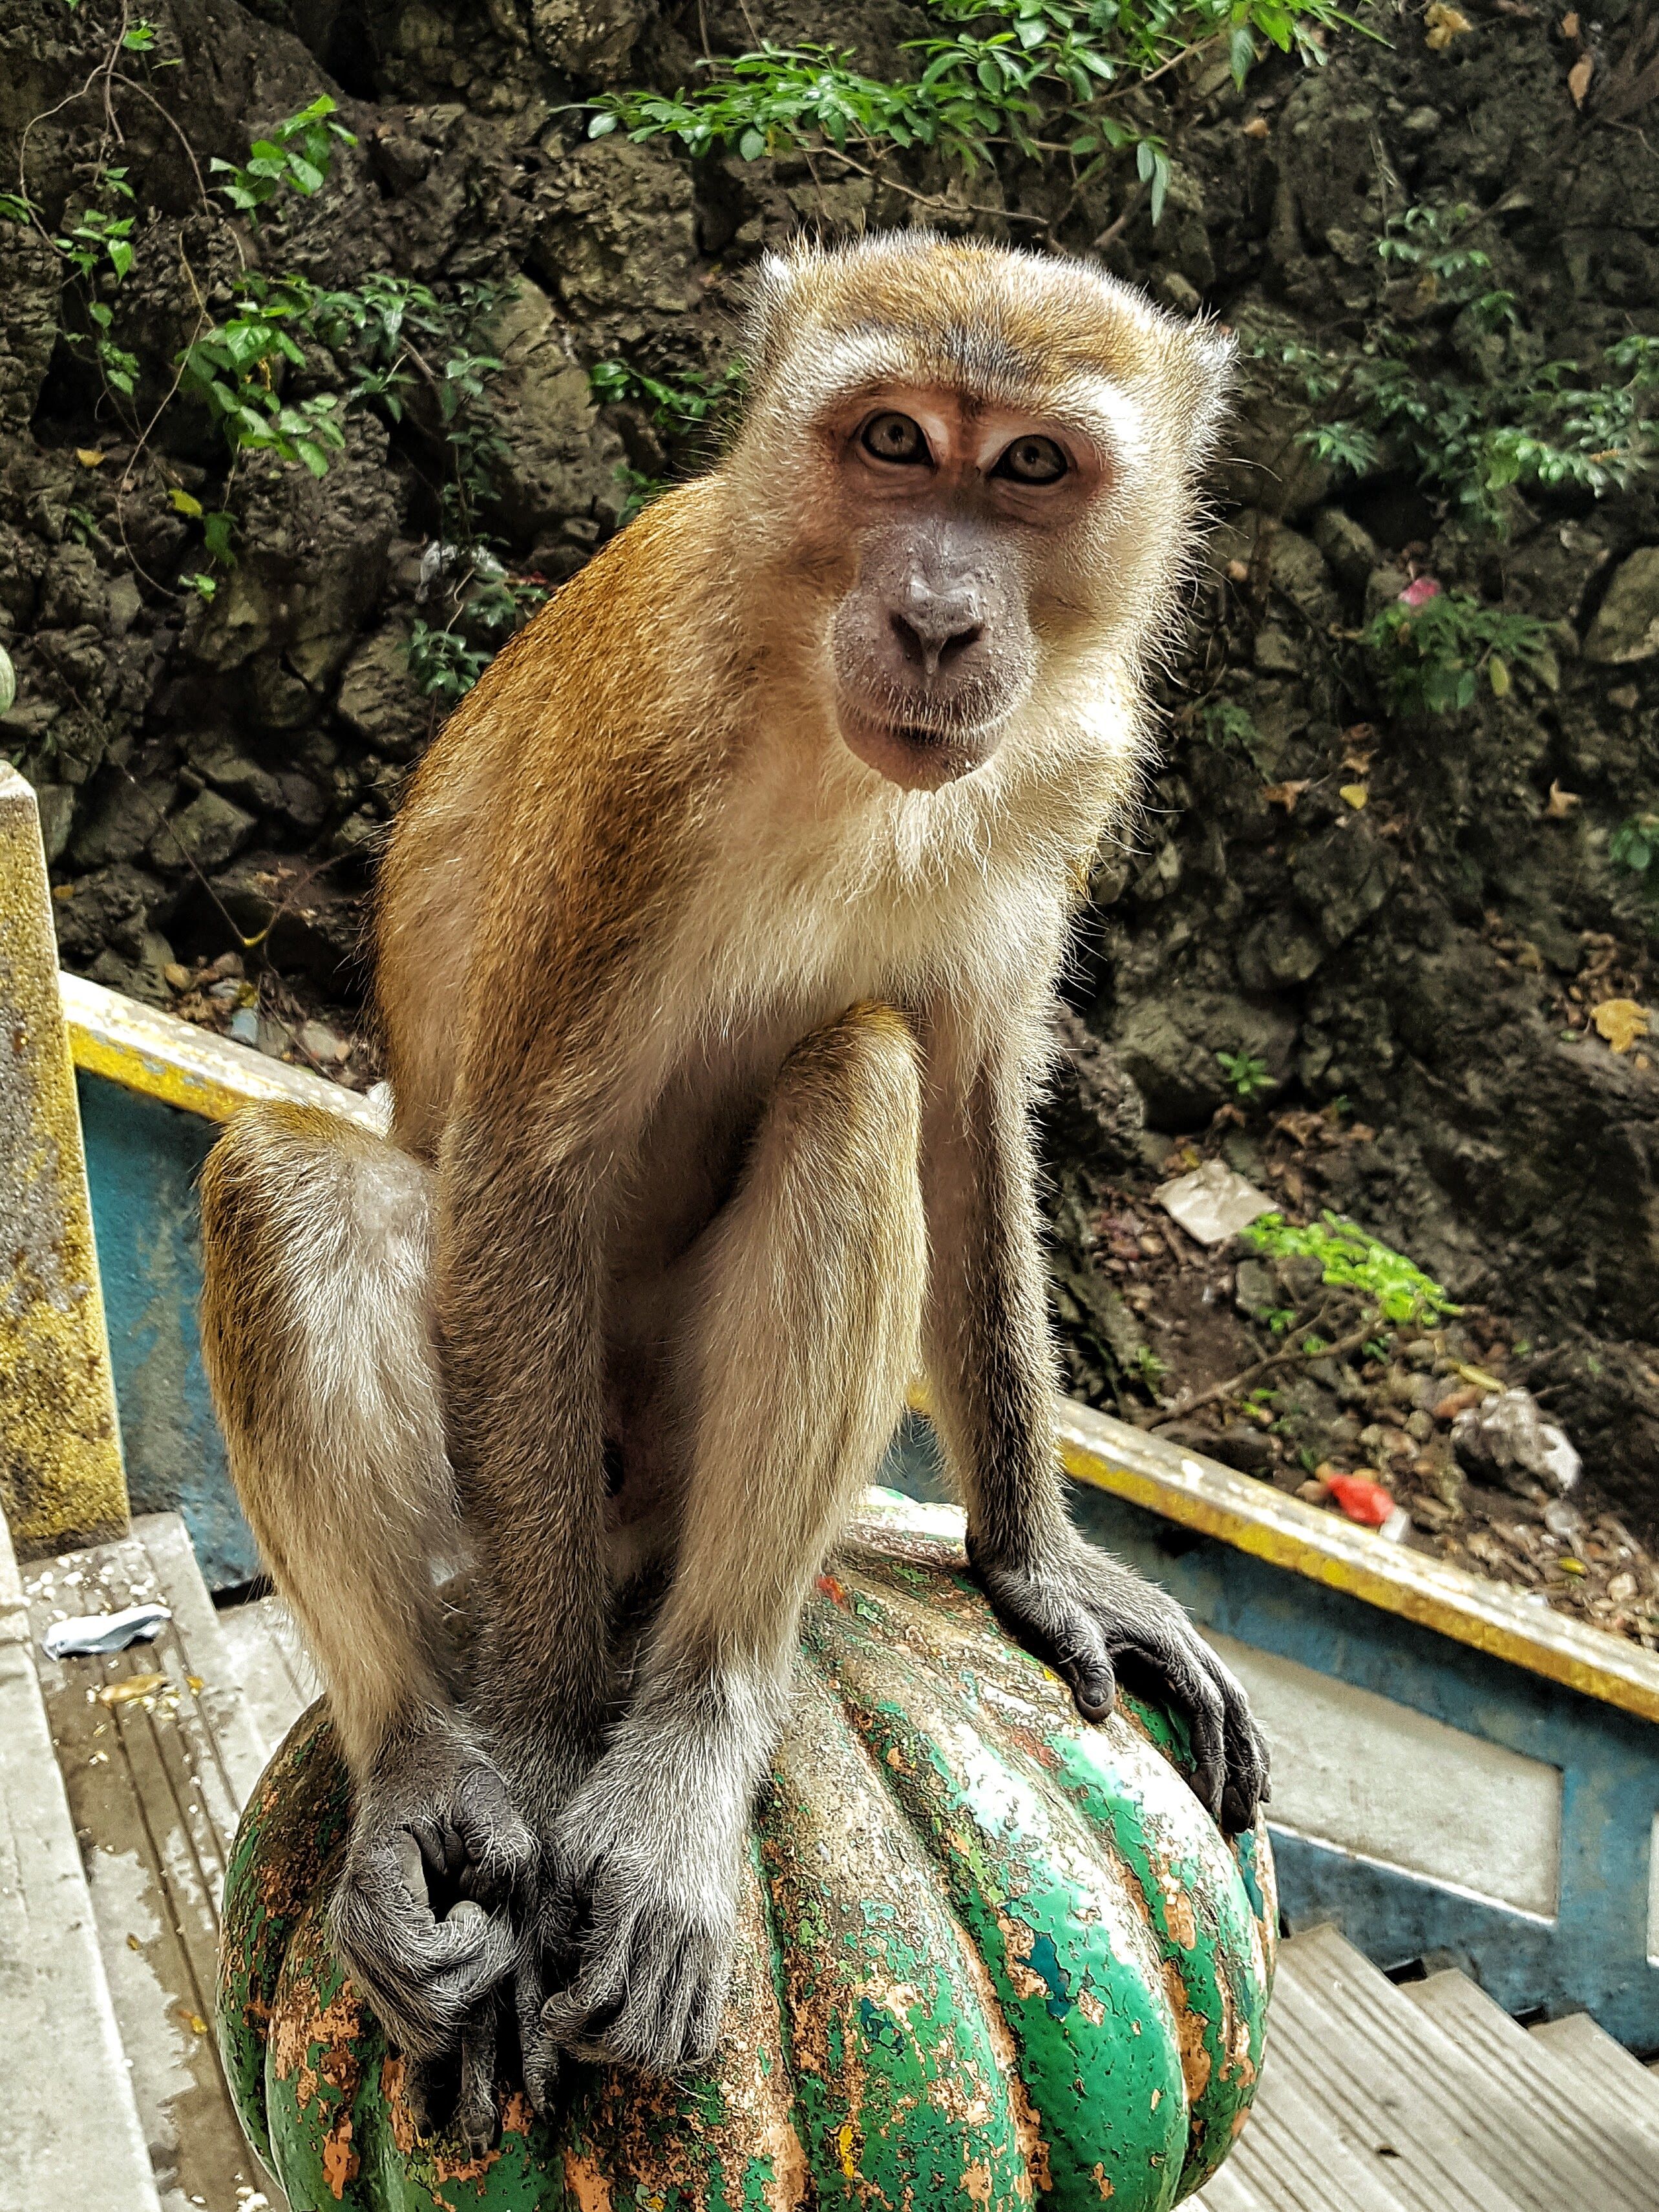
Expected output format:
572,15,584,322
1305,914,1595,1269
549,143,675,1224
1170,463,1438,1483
219,1500,1276,2212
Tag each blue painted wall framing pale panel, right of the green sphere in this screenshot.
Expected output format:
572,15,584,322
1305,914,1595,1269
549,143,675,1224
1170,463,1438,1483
883,1422,1659,2057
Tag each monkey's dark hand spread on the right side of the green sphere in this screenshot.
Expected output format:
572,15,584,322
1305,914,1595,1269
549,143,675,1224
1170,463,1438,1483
969,1535,1267,1836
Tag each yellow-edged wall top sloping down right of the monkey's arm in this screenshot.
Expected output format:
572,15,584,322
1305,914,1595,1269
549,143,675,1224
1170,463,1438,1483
911,1389,1659,1721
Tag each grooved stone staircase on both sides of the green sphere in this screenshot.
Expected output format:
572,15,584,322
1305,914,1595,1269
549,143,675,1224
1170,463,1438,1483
0,1515,1659,2212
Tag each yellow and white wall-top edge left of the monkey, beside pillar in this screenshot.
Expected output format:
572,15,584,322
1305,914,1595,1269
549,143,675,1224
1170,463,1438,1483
58,976,385,1133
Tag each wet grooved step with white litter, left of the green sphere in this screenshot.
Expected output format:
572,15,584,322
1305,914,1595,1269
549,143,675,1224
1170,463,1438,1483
26,1513,281,2212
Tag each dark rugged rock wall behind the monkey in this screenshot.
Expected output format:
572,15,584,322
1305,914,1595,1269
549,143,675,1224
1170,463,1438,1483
0,0,1659,1522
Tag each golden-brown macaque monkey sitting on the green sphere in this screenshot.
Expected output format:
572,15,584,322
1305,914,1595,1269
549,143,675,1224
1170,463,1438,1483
204,237,1267,2130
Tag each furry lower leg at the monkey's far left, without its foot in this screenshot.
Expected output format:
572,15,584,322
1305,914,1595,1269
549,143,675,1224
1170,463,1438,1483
201,1104,456,1765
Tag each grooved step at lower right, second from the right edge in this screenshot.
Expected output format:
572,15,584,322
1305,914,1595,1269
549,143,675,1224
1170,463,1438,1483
1402,1973,1659,2212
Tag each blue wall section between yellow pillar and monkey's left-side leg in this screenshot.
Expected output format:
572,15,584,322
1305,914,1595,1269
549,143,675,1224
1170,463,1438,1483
78,1073,259,1590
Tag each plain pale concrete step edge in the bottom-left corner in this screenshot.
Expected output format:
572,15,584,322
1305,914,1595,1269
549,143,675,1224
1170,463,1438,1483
0,1517,159,2212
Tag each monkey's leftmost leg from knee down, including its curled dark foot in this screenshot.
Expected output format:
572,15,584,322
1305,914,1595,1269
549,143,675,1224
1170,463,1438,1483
201,1106,531,2097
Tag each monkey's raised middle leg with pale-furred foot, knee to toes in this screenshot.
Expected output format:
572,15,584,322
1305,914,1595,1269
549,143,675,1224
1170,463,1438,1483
529,1006,925,2070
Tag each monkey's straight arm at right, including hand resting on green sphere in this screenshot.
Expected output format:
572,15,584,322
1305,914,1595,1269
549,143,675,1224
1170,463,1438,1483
922,1031,1267,1829
